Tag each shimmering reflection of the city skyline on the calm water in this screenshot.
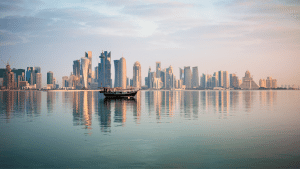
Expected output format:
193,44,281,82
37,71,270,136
0,90,277,127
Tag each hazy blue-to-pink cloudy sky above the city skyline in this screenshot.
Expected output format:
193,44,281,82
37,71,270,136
0,0,300,86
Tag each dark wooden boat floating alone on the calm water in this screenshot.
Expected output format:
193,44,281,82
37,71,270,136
99,87,139,98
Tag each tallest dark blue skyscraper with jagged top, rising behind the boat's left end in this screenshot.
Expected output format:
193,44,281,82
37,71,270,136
98,51,112,87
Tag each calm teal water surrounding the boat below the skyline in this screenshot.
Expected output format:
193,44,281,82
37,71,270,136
0,91,300,168
